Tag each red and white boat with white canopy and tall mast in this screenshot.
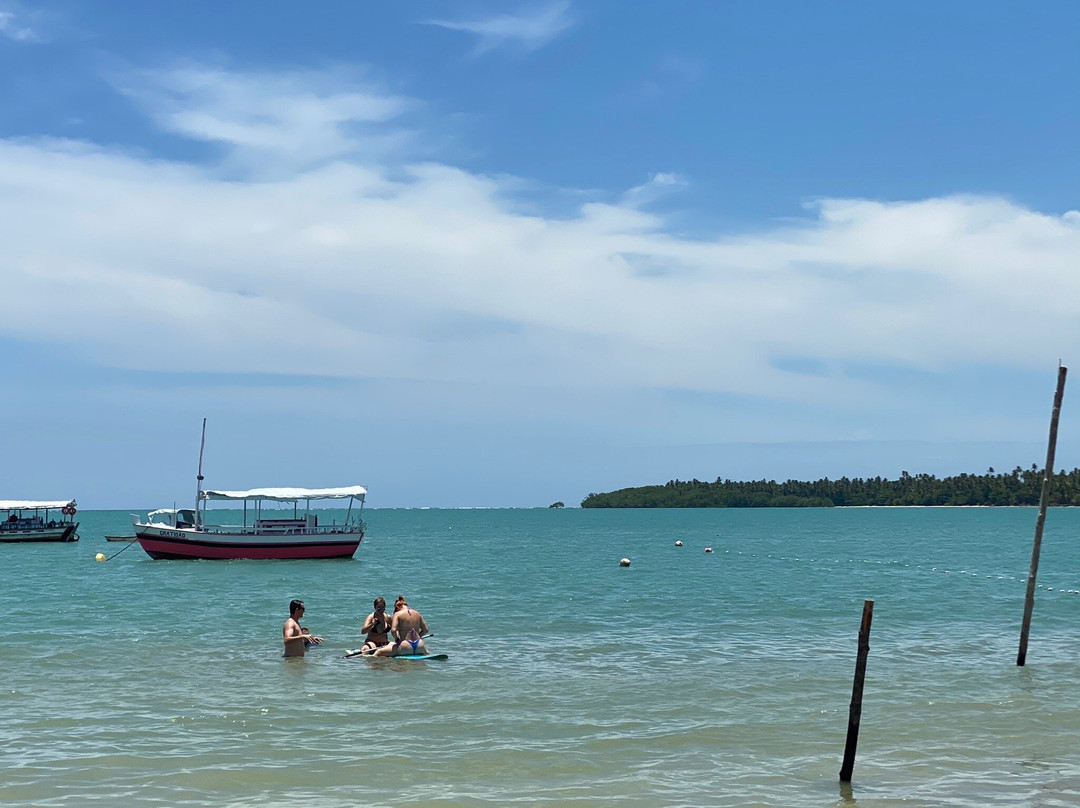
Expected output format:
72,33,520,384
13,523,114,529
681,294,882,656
132,418,367,558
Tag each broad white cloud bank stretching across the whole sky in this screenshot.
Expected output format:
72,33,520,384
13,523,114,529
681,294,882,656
0,63,1080,429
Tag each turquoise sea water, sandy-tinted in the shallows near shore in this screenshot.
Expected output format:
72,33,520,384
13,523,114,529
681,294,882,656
0,509,1080,808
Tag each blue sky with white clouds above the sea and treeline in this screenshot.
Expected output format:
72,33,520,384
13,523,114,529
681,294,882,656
0,0,1080,509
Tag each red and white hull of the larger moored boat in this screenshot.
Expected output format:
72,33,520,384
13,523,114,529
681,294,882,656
135,525,364,561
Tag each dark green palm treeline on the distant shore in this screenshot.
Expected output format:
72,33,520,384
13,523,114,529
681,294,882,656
581,464,1080,508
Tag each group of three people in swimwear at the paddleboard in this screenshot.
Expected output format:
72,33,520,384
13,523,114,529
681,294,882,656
282,595,431,657
